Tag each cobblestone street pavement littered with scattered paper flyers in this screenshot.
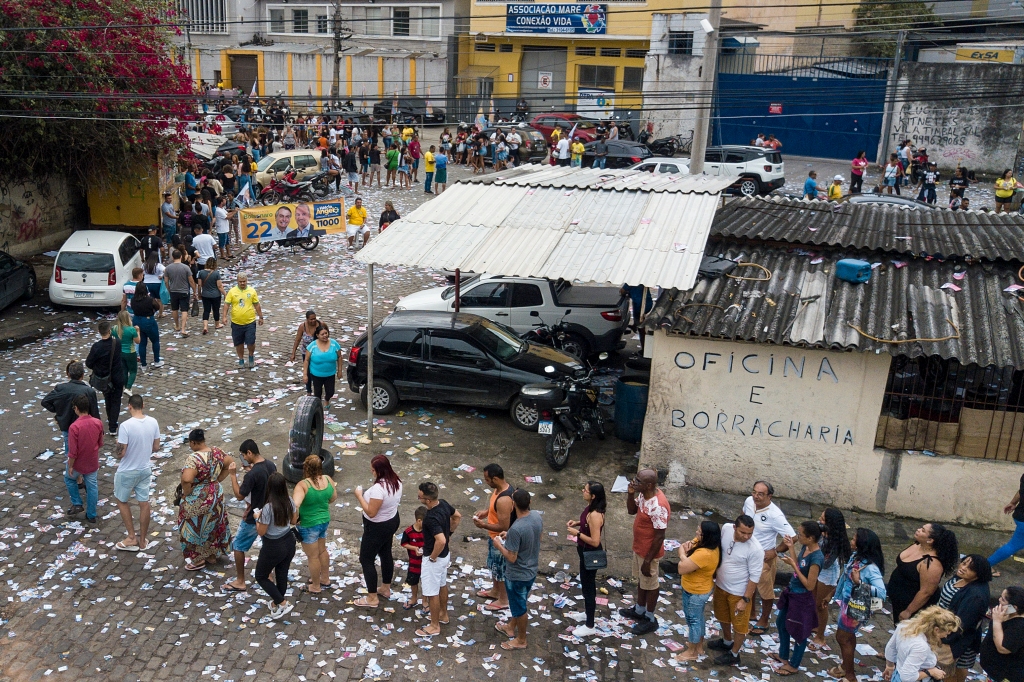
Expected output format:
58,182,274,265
0,155,978,681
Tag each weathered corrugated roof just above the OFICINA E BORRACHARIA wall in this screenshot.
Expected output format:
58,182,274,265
646,240,1024,369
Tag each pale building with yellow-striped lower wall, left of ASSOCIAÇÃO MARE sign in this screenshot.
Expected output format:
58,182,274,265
179,0,468,111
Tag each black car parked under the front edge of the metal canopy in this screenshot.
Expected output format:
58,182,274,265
345,310,584,431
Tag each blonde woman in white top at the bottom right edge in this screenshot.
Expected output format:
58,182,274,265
882,606,961,682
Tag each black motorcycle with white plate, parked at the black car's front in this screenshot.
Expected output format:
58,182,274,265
519,353,608,471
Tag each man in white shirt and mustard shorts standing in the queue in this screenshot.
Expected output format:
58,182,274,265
708,514,764,666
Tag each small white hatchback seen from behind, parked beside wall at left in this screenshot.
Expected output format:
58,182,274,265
50,229,142,308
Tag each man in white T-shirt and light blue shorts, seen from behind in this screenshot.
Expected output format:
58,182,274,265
114,393,160,552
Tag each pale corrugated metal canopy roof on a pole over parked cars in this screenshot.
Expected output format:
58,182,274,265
355,166,730,289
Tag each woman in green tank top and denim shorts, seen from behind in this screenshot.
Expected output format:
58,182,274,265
292,455,338,594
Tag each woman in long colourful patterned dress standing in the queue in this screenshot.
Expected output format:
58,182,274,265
178,429,231,570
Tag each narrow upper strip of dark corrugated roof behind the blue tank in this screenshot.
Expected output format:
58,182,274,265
712,197,1024,261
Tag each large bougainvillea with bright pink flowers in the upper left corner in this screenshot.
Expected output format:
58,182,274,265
0,0,196,182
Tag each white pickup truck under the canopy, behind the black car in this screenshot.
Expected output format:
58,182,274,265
395,274,630,357
